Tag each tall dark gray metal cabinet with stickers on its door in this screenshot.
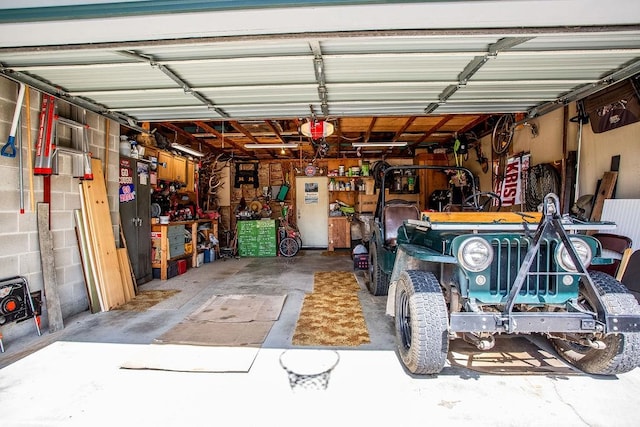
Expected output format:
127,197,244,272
118,157,153,284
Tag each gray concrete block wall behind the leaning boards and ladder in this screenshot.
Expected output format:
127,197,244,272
0,77,119,345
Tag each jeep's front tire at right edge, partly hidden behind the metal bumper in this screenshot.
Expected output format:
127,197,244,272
552,271,640,375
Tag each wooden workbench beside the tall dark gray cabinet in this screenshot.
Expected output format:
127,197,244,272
151,219,218,280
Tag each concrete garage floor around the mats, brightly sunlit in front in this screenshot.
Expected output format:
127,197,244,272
0,251,640,426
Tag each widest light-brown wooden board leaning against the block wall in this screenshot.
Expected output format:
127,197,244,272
82,159,126,310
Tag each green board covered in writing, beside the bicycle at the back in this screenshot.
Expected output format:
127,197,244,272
238,219,277,257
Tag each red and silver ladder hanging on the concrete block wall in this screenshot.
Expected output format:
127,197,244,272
33,94,93,180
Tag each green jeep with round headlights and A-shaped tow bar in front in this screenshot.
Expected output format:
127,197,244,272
367,166,640,375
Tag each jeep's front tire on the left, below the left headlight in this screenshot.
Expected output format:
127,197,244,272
395,270,449,375
